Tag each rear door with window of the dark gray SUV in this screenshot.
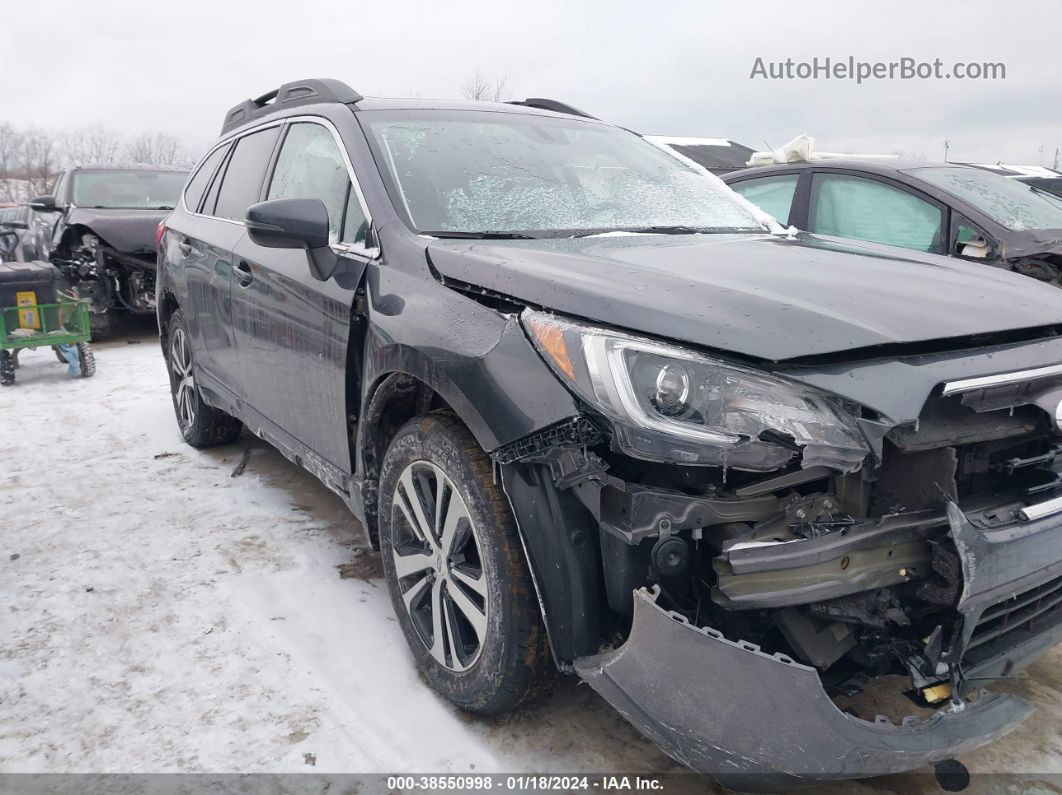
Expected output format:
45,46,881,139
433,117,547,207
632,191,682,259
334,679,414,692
176,125,280,399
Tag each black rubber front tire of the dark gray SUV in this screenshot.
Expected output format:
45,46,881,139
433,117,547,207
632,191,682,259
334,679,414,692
379,413,550,714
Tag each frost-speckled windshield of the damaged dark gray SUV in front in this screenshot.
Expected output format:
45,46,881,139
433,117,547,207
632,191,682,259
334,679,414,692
370,113,761,234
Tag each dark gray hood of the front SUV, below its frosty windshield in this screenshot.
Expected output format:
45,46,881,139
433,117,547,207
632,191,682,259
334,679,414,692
428,235,1062,361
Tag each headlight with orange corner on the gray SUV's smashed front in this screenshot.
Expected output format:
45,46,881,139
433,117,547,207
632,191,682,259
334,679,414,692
523,310,870,471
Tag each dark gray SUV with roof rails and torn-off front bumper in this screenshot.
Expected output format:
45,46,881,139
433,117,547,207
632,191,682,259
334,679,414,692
157,80,1062,779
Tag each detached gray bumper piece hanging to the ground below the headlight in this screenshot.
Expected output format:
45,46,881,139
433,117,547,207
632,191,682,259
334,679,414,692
576,589,1032,788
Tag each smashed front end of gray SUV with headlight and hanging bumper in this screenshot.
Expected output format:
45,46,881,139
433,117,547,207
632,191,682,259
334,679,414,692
495,311,1062,779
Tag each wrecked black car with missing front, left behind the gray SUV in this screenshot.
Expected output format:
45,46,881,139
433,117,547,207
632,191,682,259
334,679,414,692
31,166,188,331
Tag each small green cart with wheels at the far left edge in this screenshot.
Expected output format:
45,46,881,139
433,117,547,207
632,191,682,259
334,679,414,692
0,300,96,386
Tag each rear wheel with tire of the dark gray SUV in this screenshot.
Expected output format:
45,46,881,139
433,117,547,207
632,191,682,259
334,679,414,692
162,309,242,448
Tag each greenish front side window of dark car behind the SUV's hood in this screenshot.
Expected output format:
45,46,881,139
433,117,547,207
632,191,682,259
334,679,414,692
807,171,945,254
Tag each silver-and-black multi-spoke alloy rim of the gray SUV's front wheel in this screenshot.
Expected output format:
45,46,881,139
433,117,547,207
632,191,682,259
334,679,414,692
391,461,489,672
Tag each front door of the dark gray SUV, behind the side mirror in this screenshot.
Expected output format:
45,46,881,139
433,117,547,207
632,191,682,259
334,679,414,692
233,119,370,473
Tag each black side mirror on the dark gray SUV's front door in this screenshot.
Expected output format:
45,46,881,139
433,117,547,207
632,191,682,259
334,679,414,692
246,198,339,281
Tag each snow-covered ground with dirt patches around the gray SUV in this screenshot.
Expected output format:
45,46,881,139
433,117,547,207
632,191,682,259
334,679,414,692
0,333,1062,792
